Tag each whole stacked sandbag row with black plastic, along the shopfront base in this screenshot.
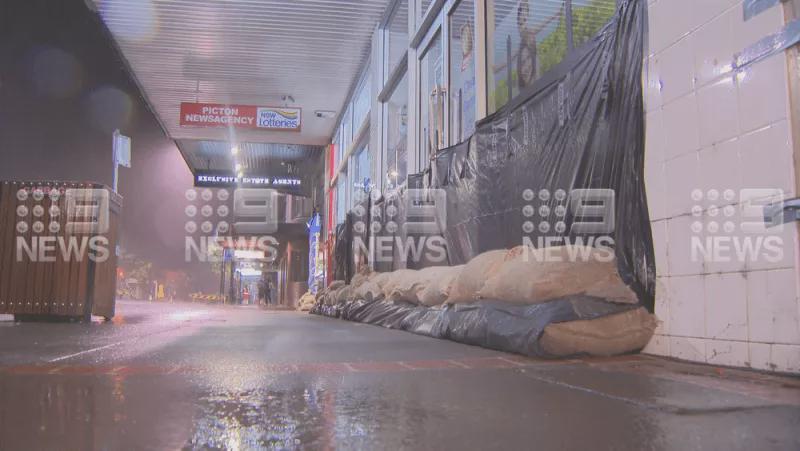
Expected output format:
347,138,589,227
312,247,656,357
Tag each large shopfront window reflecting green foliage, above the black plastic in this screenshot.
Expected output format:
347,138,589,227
487,0,567,113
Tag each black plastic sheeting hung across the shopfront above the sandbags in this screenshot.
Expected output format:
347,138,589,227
354,0,655,312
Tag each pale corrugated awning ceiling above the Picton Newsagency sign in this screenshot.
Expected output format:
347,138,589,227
86,0,390,145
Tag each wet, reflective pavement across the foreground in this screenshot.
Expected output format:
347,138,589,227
0,301,800,450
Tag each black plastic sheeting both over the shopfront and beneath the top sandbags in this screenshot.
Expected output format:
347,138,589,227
312,0,655,357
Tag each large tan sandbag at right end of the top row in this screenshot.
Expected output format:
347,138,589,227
477,246,639,304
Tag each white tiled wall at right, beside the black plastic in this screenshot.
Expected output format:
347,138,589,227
644,0,800,373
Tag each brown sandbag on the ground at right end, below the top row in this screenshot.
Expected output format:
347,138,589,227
539,307,657,357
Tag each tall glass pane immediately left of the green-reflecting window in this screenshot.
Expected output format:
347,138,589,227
448,0,477,144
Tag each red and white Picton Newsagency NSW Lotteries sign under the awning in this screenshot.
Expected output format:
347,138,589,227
181,103,301,132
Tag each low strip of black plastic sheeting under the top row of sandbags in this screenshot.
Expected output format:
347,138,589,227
311,296,637,357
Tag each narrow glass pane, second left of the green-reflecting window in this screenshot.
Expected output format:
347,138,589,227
418,32,446,169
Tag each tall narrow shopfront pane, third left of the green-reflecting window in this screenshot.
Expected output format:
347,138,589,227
386,76,408,190
